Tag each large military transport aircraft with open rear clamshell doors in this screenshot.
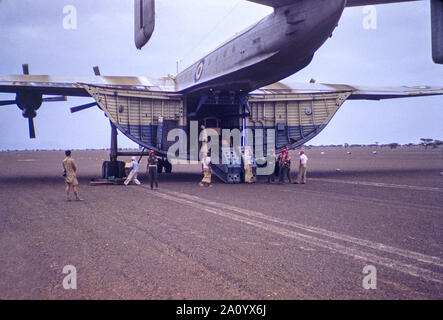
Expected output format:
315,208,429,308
0,0,443,183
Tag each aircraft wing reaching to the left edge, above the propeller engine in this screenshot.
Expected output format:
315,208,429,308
0,75,175,97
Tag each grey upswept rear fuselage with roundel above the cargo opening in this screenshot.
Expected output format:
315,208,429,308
176,0,346,93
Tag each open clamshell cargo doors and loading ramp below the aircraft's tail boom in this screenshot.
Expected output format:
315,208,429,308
84,85,352,183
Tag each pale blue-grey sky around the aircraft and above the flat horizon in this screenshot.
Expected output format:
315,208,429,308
0,0,443,150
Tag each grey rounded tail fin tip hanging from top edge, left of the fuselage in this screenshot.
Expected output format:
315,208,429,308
134,0,155,49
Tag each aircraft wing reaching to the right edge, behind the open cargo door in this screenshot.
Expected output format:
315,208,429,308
252,82,443,100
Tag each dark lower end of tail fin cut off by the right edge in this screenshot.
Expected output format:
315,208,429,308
431,0,443,64
